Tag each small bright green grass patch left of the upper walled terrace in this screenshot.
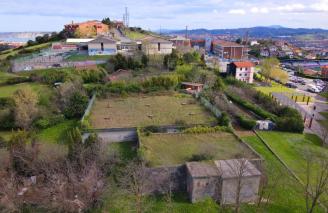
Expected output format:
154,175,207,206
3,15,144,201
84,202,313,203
37,120,76,144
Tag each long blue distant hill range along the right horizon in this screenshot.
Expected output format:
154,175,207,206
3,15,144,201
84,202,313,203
165,25,328,38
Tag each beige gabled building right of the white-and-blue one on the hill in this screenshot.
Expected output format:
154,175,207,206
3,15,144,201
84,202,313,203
142,37,173,55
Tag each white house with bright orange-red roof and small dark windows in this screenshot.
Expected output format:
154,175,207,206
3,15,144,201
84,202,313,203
229,61,255,84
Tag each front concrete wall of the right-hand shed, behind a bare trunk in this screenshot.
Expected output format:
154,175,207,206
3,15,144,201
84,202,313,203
219,176,261,204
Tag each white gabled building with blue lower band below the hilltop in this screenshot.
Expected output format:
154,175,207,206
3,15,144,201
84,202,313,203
88,37,117,55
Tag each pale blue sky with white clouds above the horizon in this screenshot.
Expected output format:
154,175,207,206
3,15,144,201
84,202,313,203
0,0,328,32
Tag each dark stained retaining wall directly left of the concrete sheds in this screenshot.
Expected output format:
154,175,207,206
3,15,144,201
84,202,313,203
145,165,187,194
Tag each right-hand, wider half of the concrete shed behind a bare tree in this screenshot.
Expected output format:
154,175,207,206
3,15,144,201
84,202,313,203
215,159,262,205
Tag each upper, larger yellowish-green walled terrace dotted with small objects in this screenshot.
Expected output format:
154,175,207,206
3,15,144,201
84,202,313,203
90,94,216,129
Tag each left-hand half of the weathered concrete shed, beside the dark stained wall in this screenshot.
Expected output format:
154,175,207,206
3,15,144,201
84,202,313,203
186,162,219,203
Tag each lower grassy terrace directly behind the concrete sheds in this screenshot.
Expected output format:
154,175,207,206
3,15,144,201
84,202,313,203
141,132,256,166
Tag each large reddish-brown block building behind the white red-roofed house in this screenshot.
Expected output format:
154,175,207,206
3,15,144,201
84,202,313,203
211,40,248,60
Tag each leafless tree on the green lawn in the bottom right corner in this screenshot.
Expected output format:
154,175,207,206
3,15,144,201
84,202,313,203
305,156,328,213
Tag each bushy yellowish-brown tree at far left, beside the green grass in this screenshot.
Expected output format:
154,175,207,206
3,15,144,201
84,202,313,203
13,88,38,129
